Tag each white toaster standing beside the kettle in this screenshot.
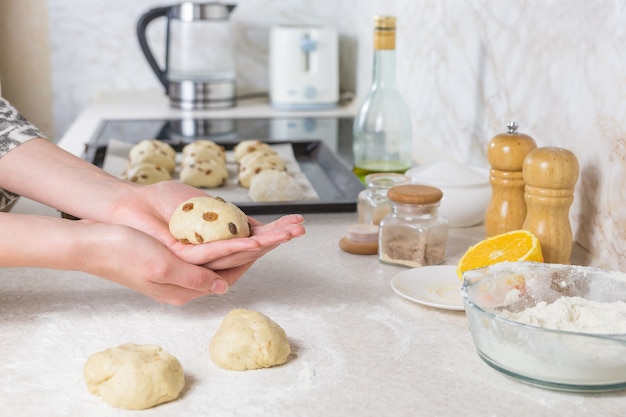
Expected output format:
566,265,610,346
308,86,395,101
269,25,339,110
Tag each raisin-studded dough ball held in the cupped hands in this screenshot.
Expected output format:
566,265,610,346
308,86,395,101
169,196,250,244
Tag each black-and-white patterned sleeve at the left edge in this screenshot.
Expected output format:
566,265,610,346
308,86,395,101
0,97,45,210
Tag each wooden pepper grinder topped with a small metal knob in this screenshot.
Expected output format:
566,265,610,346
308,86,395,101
485,122,537,237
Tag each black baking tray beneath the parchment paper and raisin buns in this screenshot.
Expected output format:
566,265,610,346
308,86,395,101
83,124,364,215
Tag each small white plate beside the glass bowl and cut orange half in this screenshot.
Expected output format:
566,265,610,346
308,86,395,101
391,265,464,311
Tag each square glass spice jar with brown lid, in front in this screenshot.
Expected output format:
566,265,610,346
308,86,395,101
378,185,448,268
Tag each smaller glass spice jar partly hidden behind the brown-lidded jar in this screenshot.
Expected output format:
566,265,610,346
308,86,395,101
357,173,411,225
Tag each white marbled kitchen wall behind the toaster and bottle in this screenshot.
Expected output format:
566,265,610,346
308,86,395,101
49,0,626,270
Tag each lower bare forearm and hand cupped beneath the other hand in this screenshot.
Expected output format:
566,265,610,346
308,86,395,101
0,213,230,305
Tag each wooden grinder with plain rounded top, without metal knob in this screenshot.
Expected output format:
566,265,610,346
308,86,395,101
522,147,578,264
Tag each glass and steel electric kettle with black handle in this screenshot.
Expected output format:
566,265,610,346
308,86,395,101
137,2,235,110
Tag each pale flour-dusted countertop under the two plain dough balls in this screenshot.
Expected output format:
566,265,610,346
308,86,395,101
0,94,626,417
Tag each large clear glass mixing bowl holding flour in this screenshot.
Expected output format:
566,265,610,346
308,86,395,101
461,262,626,392
